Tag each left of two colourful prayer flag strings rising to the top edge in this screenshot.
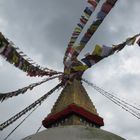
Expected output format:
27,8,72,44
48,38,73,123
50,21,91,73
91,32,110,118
64,0,100,61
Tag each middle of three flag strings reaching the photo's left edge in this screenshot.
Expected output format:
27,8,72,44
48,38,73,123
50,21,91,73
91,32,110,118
0,76,60,102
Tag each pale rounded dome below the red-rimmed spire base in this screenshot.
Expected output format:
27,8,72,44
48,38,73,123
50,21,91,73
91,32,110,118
23,125,125,140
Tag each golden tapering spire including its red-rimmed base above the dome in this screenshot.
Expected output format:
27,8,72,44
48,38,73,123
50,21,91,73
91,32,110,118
43,79,103,128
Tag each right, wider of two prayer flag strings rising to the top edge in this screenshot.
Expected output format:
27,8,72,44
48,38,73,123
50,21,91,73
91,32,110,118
75,0,117,56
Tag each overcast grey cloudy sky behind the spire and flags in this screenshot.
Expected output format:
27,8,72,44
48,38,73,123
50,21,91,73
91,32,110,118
0,0,140,140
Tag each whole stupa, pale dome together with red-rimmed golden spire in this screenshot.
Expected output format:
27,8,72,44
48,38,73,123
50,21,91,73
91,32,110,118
23,79,124,140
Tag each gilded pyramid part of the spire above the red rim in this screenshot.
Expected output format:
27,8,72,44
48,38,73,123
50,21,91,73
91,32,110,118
51,80,98,115
